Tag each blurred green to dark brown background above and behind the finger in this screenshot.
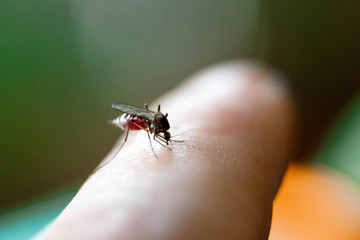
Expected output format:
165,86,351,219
0,0,360,208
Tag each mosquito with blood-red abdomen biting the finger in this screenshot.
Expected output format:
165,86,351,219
92,103,183,174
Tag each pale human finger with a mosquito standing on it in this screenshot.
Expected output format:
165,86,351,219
43,62,292,240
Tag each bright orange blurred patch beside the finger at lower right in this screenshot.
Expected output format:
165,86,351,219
269,164,360,240
